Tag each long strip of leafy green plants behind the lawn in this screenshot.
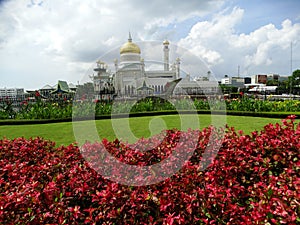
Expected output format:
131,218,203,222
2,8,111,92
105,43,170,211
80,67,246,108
0,97,300,120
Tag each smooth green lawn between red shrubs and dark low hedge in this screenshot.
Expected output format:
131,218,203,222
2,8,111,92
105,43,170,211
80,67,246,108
0,115,300,145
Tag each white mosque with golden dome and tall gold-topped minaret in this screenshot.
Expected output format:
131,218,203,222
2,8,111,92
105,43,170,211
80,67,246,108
91,33,216,99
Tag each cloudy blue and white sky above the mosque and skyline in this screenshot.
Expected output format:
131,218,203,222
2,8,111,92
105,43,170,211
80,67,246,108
0,0,300,90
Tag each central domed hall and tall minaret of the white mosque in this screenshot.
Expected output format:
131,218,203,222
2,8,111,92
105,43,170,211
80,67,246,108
114,34,180,96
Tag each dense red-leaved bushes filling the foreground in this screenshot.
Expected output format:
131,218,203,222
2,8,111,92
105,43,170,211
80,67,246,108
0,116,300,224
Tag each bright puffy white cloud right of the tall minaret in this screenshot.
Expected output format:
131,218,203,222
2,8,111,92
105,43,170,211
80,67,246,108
179,8,300,76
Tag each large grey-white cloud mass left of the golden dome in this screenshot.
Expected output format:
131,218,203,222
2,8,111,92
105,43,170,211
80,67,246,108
0,0,223,88
